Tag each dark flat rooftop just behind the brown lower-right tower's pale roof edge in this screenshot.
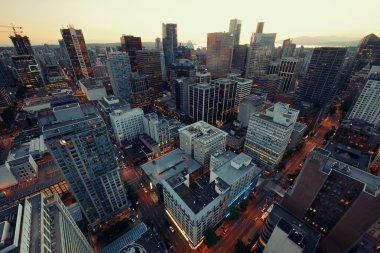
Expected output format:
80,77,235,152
325,141,371,171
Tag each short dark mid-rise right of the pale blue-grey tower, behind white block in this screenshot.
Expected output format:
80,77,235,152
131,74,152,111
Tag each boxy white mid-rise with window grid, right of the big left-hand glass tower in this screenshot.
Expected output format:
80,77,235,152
110,108,144,143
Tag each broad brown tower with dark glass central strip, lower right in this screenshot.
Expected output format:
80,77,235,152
282,142,380,252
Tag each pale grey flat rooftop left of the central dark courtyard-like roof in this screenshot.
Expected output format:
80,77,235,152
140,149,202,185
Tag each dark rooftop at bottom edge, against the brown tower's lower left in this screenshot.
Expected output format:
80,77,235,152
268,204,320,253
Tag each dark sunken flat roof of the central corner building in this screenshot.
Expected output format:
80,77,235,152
167,174,219,214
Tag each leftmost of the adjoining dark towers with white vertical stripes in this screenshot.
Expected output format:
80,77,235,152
189,83,219,125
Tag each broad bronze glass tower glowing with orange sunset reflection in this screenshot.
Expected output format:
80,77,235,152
206,33,234,78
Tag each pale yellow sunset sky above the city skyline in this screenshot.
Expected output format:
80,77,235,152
0,0,380,46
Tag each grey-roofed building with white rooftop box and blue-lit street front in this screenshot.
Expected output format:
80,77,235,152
210,151,262,206
